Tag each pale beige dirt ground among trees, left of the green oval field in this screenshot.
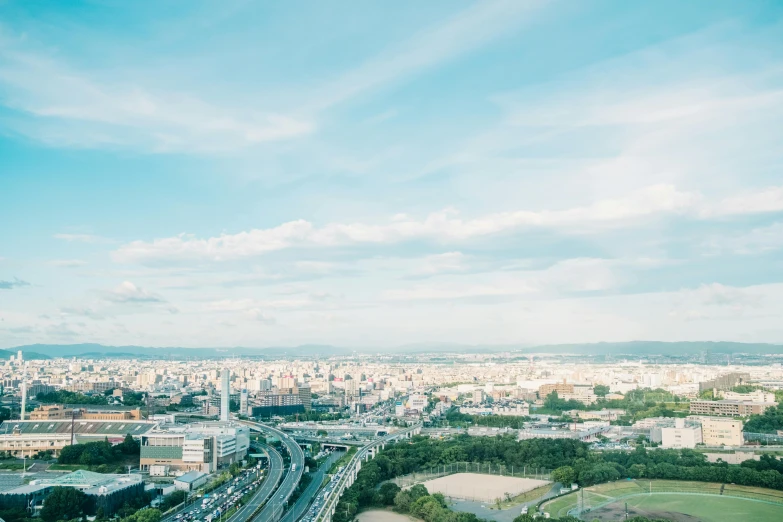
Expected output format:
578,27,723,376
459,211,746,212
422,473,550,502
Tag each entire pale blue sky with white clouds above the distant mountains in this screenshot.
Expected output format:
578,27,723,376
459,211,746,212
0,0,783,348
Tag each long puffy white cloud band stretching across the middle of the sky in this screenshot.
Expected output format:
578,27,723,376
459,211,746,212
112,185,773,264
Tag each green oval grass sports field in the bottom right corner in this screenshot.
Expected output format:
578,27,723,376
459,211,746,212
541,480,783,522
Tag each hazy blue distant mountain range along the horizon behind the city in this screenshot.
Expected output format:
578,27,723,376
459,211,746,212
6,341,783,360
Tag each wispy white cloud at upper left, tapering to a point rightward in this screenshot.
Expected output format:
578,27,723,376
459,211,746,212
0,38,314,152
